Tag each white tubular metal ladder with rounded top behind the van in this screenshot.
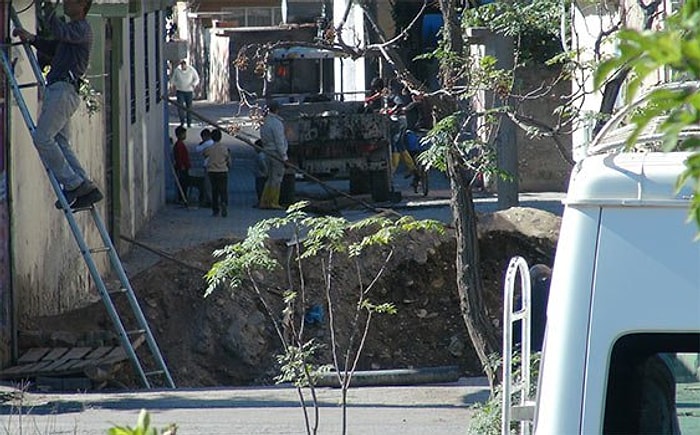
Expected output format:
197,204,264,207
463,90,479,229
501,257,534,435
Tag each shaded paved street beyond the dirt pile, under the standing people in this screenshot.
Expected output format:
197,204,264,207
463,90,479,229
123,102,564,274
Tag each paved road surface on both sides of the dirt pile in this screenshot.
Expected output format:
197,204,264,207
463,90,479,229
0,103,563,435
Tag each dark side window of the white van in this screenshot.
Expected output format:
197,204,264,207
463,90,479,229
603,334,700,434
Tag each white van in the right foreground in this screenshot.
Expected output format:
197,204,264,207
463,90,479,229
504,90,700,435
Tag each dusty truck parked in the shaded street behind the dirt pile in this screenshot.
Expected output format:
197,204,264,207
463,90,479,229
266,46,392,202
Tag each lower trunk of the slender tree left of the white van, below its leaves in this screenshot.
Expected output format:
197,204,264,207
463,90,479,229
447,153,501,391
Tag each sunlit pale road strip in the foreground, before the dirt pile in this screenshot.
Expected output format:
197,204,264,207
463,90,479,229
0,378,488,435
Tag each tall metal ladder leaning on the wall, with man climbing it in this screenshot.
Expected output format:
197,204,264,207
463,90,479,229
0,6,175,388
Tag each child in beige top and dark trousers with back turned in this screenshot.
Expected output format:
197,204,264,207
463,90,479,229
204,129,231,217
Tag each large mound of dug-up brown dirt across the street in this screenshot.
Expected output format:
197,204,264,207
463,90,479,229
20,208,560,387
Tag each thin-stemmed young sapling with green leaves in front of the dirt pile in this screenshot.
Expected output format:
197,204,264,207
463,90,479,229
206,202,444,434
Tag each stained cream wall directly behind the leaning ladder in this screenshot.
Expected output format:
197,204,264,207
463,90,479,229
9,48,110,321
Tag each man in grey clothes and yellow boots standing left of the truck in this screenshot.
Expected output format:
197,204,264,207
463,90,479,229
259,100,289,210
